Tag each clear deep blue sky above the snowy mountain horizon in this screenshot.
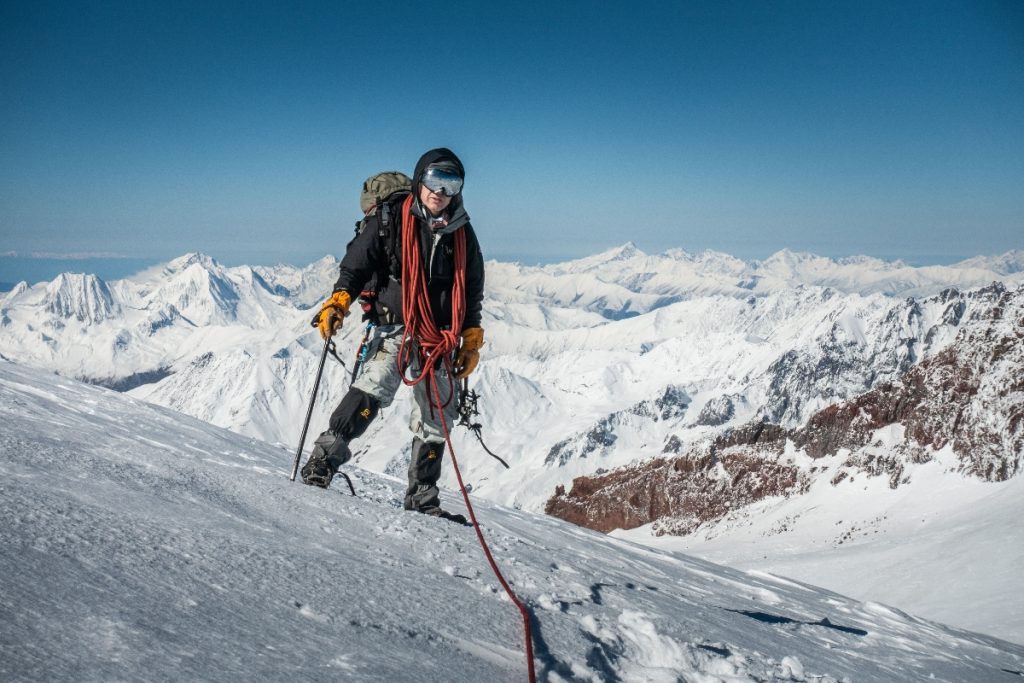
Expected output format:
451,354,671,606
0,0,1024,281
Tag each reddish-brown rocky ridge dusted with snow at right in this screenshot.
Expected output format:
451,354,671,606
545,284,1024,535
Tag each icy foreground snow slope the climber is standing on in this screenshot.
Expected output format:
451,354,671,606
0,361,1024,682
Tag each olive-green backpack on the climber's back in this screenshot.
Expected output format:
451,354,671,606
355,171,413,319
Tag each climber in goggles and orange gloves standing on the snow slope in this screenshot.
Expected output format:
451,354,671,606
302,147,483,523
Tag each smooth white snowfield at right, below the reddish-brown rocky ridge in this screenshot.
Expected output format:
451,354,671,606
613,447,1024,643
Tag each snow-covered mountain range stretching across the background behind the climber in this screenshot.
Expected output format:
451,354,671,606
0,245,1024,641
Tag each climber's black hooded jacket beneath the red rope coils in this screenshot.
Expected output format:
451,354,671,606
334,147,483,329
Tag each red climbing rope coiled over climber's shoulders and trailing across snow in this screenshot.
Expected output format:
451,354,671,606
398,195,537,683
